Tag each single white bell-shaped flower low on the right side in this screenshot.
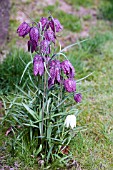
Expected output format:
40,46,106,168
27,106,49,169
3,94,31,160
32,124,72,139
64,115,76,129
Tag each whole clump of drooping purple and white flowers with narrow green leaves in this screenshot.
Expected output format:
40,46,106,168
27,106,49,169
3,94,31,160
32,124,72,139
2,16,82,168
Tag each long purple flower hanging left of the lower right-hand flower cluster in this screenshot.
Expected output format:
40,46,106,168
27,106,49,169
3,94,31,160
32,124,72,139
33,55,44,76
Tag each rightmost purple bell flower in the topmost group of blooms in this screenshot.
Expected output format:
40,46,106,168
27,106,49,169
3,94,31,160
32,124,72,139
49,18,63,32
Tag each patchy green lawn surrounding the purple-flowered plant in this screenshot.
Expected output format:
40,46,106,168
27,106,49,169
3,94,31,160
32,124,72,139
0,0,113,170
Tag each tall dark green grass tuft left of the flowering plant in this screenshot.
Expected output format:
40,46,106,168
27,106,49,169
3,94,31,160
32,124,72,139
0,49,32,94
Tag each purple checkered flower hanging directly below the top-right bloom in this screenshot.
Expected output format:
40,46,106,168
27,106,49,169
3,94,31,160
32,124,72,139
44,30,56,43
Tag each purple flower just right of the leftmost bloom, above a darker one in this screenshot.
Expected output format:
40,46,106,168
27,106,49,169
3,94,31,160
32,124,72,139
29,27,40,43
